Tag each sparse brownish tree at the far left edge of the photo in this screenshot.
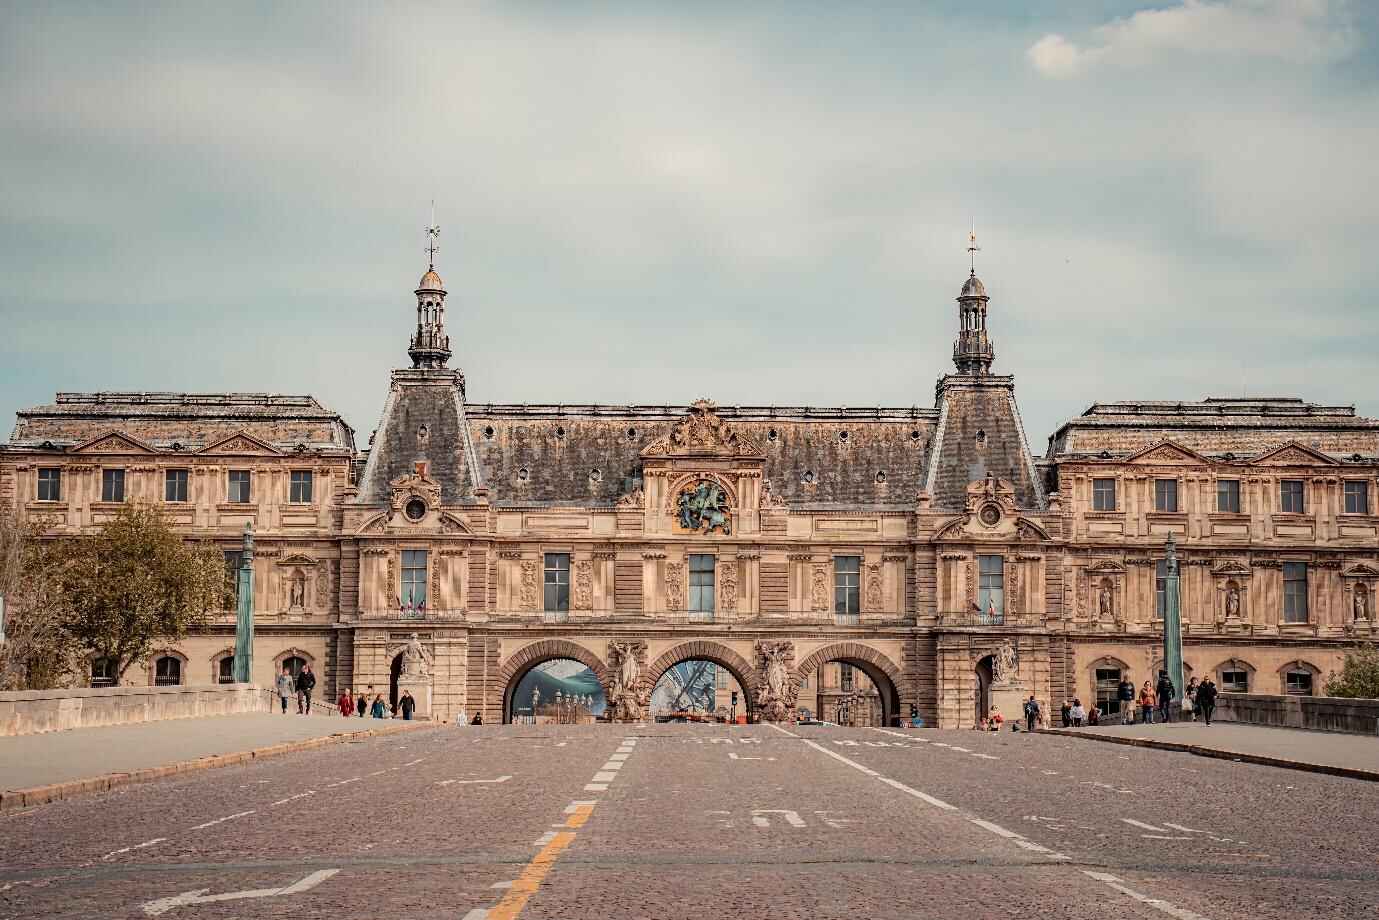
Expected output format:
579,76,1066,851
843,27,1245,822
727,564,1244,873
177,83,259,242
0,508,80,690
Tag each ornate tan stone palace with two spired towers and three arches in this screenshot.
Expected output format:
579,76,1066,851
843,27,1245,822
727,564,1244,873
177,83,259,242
0,259,1379,727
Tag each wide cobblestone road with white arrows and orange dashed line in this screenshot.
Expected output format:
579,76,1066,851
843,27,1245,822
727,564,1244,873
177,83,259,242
0,726,1379,920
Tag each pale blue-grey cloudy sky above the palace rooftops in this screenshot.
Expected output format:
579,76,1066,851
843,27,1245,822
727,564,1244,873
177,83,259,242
0,0,1379,454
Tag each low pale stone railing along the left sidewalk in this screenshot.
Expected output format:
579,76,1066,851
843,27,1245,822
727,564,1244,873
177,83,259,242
0,684,273,735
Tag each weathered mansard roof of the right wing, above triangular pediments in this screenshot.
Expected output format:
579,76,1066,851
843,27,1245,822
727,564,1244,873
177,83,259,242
1047,397,1379,461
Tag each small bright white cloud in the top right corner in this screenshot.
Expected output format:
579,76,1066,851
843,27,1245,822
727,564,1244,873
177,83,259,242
1026,0,1356,79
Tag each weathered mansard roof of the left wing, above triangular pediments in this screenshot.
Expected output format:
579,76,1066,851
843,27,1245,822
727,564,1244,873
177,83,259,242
8,392,354,455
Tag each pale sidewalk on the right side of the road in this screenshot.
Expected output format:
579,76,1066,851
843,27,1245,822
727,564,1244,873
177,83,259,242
1049,721,1379,781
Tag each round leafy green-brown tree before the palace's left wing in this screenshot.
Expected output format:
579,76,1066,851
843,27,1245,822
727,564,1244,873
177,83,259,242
54,503,226,683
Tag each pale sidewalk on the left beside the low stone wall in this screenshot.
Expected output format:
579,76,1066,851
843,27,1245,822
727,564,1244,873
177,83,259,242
0,713,440,810
